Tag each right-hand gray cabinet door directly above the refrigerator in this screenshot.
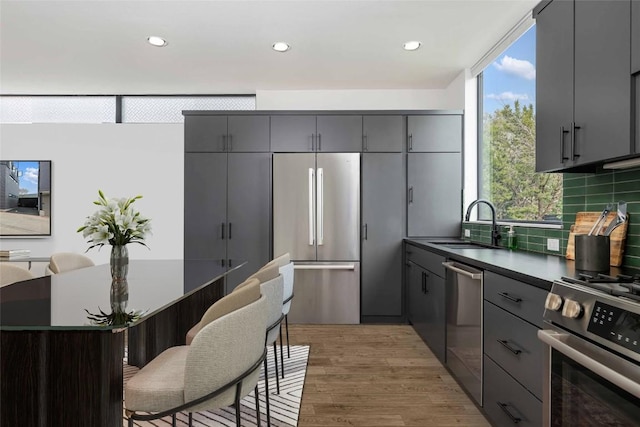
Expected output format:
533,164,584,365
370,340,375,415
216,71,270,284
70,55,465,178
315,115,362,153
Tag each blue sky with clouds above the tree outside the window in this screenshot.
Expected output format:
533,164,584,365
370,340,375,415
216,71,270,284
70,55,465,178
483,25,536,113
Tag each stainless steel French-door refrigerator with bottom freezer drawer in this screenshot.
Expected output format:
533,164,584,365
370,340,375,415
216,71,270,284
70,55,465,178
273,153,360,324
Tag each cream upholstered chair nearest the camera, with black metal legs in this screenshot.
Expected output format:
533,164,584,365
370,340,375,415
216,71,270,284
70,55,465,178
124,285,268,427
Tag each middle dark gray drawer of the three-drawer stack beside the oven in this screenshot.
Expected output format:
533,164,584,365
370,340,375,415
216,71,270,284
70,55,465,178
484,301,543,399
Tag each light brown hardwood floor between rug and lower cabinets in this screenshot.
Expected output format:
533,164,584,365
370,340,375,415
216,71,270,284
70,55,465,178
285,325,489,427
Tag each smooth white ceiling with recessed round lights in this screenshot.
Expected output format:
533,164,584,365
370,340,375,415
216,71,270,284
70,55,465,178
0,0,537,95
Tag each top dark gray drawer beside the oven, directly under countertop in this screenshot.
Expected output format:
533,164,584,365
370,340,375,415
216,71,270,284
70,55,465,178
484,271,547,327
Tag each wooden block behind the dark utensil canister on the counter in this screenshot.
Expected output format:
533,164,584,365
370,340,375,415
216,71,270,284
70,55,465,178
566,211,629,267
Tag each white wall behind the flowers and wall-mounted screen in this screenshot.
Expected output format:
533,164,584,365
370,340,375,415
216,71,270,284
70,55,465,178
0,124,184,273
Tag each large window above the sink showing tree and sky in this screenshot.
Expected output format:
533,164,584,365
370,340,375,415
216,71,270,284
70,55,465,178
478,26,562,223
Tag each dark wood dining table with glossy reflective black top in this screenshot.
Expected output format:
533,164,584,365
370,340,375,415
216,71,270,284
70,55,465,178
0,260,245,427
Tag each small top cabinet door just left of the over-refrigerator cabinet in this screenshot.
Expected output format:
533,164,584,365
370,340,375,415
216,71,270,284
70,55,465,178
227,116,270,152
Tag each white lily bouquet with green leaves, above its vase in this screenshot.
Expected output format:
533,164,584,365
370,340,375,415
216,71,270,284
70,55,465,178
78,190,151,251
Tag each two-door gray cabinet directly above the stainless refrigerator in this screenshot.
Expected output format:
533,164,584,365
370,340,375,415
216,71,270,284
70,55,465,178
271,114,362,152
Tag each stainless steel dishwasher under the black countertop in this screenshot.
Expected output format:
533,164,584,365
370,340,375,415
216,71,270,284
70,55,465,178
442,261,484,406
